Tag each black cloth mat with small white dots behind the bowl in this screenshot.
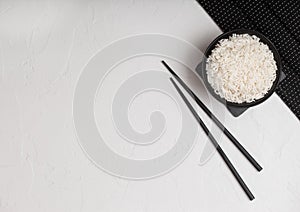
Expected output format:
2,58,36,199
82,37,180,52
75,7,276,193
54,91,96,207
197,0,300,119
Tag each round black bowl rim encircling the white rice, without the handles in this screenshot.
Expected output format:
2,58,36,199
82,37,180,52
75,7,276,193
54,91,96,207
201,29,282,107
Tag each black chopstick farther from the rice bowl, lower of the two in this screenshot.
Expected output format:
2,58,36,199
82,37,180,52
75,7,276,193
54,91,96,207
170,78,255,200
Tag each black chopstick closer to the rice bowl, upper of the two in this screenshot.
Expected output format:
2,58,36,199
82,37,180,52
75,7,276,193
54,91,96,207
161,61,262,171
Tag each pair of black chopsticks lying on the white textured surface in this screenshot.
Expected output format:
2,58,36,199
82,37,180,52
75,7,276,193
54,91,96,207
162,61,262,200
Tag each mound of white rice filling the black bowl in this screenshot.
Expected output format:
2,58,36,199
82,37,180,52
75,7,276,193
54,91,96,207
206,34,277,103
